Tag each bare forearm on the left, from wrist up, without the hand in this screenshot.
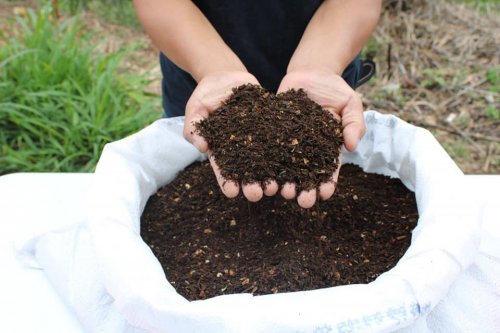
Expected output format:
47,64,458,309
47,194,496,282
134,0,246,82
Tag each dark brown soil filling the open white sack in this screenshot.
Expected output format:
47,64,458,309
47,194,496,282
141,162,418,300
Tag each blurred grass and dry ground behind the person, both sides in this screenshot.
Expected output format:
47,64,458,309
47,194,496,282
0,0,500,175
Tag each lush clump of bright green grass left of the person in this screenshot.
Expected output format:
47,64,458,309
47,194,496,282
0,7,159,174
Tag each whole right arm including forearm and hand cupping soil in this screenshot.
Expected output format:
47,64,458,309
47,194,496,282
278,0,382,208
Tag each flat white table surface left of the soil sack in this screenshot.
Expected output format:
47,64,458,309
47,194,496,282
0,173,89,333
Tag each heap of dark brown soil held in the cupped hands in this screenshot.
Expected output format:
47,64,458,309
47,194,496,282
196,84,343,191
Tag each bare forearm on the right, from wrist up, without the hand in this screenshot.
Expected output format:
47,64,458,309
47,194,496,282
288,0,382,75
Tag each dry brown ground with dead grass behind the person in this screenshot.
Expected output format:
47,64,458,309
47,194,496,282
0,0,500,174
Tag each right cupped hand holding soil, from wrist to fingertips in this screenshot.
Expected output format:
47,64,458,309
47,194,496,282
278,70,365,208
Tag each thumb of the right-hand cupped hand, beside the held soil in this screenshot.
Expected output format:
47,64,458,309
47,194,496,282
340,93,366,151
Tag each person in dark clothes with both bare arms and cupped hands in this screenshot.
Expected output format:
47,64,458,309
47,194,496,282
134,0,382,208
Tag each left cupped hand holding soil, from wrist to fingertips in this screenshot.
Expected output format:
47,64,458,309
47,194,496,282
184,71,270,202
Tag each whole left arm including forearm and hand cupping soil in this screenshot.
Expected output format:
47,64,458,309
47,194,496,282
134,0,262,201
